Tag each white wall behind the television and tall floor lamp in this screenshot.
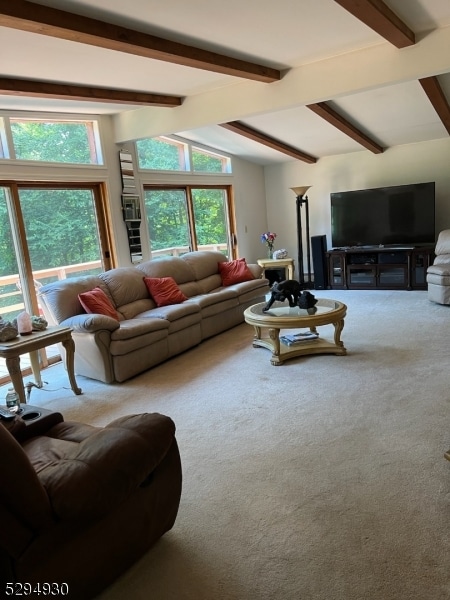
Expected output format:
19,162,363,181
265,138,450,278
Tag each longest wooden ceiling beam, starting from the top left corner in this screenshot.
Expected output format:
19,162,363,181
0,0,281,83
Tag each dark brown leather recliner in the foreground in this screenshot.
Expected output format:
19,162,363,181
0,413,181,600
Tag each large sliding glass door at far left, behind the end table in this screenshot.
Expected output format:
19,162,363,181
0,183,112,384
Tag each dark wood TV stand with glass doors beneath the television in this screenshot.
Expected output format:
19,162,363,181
327,246,434,290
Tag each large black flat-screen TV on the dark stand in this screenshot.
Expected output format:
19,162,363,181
330,182,435,248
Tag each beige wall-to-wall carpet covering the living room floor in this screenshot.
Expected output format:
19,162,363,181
9,290,450,600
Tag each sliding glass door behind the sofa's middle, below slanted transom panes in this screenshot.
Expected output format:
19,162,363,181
144,186,235,257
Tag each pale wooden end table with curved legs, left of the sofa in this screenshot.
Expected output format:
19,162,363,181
0,327,82,404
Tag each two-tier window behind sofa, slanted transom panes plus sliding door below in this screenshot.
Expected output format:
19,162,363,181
136,136,237,258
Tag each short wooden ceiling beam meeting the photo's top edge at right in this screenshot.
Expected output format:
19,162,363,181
334,0,416,48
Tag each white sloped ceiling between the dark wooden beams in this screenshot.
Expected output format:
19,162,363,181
0,0,450,164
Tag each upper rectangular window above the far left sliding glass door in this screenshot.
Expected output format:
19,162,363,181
9,118,103,165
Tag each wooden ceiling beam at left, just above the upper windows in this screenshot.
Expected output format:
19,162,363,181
0,77,183,108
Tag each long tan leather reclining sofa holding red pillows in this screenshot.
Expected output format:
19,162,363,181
39,251,269,383
